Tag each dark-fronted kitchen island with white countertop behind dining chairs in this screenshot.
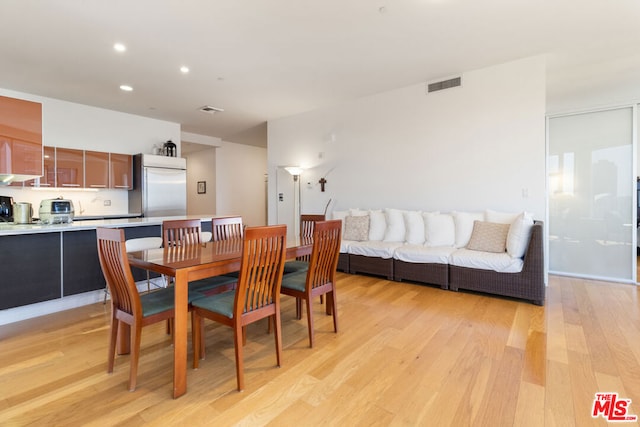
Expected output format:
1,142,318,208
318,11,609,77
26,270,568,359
0,215,212,325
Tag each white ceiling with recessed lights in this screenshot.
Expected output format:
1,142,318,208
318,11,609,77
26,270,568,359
0,0,640,149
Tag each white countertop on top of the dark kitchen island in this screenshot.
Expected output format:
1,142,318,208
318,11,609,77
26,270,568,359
0,215,215,237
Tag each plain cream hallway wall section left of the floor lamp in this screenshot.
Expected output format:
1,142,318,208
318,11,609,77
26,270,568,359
216,141,267,226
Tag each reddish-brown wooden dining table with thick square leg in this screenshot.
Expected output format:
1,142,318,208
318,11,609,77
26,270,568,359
126,239,312,398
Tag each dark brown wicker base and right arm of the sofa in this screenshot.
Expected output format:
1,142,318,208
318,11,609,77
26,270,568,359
340,221,546,305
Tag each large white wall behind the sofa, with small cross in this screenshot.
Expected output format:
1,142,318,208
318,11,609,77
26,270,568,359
268,57,546,222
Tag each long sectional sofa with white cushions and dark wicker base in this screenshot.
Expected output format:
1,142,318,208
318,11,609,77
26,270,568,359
332,209,545,305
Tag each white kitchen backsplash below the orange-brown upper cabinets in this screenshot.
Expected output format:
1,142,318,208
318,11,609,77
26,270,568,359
0,187,129,218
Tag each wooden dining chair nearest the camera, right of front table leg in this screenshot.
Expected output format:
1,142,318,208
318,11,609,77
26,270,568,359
193,225,287,391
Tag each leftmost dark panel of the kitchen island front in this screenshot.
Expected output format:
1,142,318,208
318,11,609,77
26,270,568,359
0,232,60,310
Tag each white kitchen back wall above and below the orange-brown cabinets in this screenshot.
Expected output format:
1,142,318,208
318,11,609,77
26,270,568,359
0,88,180,215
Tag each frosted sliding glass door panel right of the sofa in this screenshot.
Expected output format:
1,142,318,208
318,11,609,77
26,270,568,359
548,107,637,282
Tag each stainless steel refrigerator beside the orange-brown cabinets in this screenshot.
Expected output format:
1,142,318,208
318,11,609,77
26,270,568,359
129,154,187,217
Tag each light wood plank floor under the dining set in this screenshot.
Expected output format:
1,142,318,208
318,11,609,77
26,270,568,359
0,274,640,426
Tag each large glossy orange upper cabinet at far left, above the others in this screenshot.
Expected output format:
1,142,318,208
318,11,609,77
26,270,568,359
0,96,42,176
